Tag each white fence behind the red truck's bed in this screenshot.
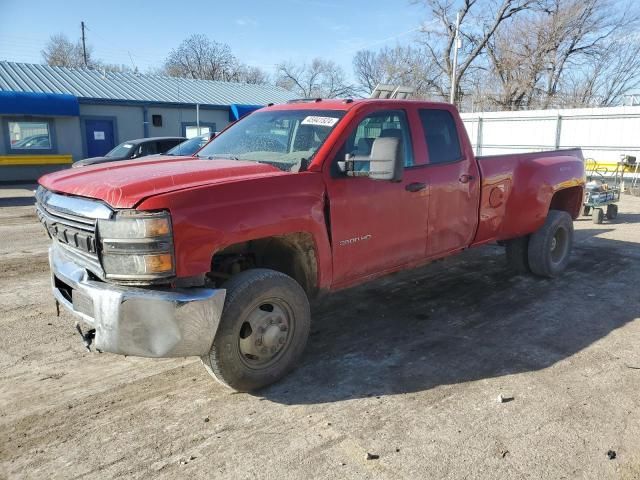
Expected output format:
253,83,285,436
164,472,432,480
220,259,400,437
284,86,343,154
462,107,640,164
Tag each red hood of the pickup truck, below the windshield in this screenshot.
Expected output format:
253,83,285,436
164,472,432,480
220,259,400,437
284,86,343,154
38,156,286,208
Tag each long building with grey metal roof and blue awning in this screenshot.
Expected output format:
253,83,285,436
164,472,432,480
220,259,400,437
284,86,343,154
0,61,295,182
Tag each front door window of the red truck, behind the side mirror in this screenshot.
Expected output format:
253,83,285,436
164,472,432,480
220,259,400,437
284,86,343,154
344,110,414,171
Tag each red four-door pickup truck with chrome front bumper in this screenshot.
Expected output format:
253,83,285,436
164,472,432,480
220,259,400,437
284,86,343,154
36,99,585,391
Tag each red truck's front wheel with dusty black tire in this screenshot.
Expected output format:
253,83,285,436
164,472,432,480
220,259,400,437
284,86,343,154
201,269,311,392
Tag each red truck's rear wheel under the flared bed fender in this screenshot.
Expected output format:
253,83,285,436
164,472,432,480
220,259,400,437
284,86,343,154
529,210,573,278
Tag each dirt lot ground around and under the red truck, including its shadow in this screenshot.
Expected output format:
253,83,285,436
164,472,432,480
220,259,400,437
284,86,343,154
0,187,640,479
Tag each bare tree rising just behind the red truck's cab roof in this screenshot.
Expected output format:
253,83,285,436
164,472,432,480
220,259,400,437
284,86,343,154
276,58,355,98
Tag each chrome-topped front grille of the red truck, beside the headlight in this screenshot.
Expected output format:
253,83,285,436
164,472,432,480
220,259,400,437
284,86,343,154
36,187,113,277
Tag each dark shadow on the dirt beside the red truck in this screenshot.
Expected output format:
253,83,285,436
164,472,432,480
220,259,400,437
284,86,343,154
259,229,640,404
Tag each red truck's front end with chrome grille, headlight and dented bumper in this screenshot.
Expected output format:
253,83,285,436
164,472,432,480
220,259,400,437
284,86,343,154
36,187,225,357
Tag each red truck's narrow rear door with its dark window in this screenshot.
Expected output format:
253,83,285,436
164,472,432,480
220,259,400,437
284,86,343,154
418,108,480,257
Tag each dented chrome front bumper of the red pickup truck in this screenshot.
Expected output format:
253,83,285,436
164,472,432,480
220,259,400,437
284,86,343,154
49,246,226,357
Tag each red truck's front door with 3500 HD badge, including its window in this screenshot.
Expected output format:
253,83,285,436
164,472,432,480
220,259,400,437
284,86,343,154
327,110,429,287
